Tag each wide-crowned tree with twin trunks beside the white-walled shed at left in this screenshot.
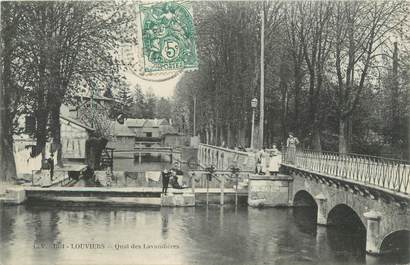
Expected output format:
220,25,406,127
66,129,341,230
2,2,132,167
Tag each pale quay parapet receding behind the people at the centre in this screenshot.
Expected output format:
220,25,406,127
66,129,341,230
198,144,256,171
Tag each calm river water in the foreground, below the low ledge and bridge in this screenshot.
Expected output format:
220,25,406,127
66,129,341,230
0,205,404,265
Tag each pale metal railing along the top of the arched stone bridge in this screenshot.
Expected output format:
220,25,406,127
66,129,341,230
282,150,410,194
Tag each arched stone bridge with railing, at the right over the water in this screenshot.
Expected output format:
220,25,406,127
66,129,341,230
281,148,410,254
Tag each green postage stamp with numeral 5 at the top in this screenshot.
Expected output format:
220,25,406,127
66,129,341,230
139,2,198,73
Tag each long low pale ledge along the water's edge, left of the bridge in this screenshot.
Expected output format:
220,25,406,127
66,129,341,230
8,184,248,207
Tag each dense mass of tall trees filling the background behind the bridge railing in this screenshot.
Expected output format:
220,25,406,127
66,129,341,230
174,1,409,158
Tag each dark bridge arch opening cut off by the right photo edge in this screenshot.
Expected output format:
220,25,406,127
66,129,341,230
380,230,410,256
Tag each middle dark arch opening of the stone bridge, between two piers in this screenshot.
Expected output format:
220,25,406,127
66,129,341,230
327,203,366,231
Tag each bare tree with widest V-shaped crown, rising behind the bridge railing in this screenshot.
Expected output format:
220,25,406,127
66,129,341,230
332,2,405,153
